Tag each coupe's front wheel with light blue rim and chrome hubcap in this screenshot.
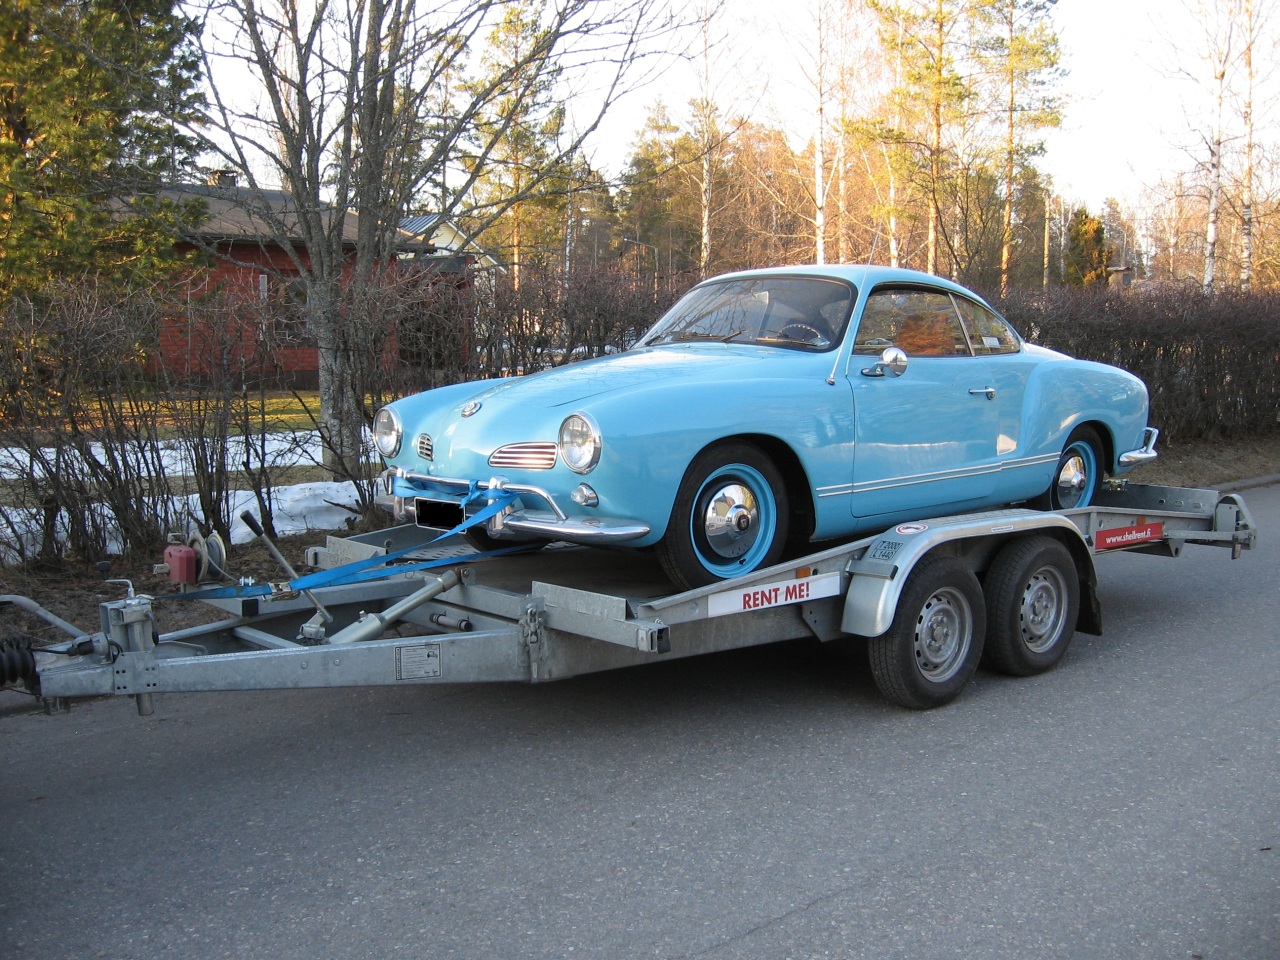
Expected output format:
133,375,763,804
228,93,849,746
658,443,787,590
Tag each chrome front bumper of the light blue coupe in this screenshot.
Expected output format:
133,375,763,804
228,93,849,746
375,467,649,544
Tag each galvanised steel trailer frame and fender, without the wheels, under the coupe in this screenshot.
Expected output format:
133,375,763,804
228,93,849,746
5,483,1257,713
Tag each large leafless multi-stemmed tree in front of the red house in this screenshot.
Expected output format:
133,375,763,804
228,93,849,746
190,0,677,476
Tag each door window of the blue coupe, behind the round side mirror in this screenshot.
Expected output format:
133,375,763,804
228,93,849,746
854,289,969,357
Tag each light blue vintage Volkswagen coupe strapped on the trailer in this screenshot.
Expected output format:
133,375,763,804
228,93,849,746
374,266,1156,588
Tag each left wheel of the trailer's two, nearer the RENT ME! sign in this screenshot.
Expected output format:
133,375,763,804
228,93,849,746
869,557,987,710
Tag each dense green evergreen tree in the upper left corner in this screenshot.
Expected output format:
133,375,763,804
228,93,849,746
0,0,198,300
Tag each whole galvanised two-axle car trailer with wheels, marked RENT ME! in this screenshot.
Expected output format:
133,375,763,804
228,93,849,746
0,480,1257,716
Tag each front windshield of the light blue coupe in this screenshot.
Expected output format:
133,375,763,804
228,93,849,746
636,276,856,351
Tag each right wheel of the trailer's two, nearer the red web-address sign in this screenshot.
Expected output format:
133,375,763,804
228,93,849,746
983,536,1080,677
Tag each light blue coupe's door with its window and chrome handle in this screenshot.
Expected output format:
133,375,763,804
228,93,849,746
849,287,1000,517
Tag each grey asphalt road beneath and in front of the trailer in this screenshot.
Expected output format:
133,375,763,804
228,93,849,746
0,486,1280,960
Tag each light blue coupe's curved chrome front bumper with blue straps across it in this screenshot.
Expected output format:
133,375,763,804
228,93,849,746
375,467,650,544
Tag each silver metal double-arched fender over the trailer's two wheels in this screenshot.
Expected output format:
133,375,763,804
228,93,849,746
841,509,1098,637
